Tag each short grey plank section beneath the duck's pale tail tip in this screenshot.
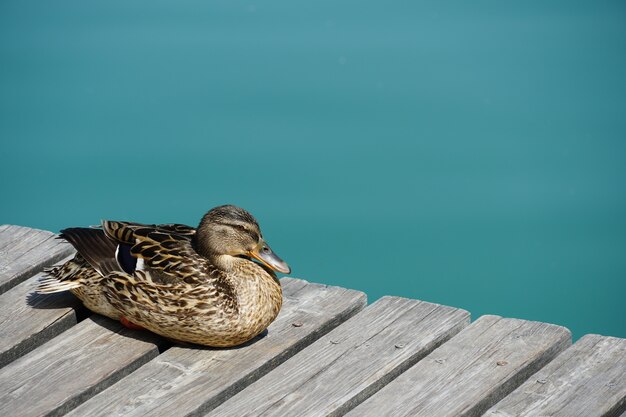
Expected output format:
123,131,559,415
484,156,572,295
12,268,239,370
0,257,83,368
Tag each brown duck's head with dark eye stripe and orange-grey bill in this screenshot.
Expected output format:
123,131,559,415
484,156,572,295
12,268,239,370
196,205,291,274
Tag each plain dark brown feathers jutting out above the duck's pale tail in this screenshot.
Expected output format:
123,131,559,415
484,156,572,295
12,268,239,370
61,227,117,275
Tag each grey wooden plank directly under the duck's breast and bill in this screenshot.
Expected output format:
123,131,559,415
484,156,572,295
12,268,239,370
66,278,366,416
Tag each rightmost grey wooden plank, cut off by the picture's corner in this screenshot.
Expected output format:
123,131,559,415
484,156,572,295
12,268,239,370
485,335,626,417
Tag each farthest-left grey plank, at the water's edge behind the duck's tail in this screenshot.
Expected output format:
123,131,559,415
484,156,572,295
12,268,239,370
0,225,73,294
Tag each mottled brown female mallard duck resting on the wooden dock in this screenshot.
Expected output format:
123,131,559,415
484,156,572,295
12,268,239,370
37,206,290,347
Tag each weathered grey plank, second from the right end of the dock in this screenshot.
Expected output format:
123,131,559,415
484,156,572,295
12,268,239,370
346,316,571,417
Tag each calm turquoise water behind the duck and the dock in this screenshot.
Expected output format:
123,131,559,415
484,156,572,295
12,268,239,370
0,0,626,337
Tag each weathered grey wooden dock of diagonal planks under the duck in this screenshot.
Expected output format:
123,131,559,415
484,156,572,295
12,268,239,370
0,225,626,417
